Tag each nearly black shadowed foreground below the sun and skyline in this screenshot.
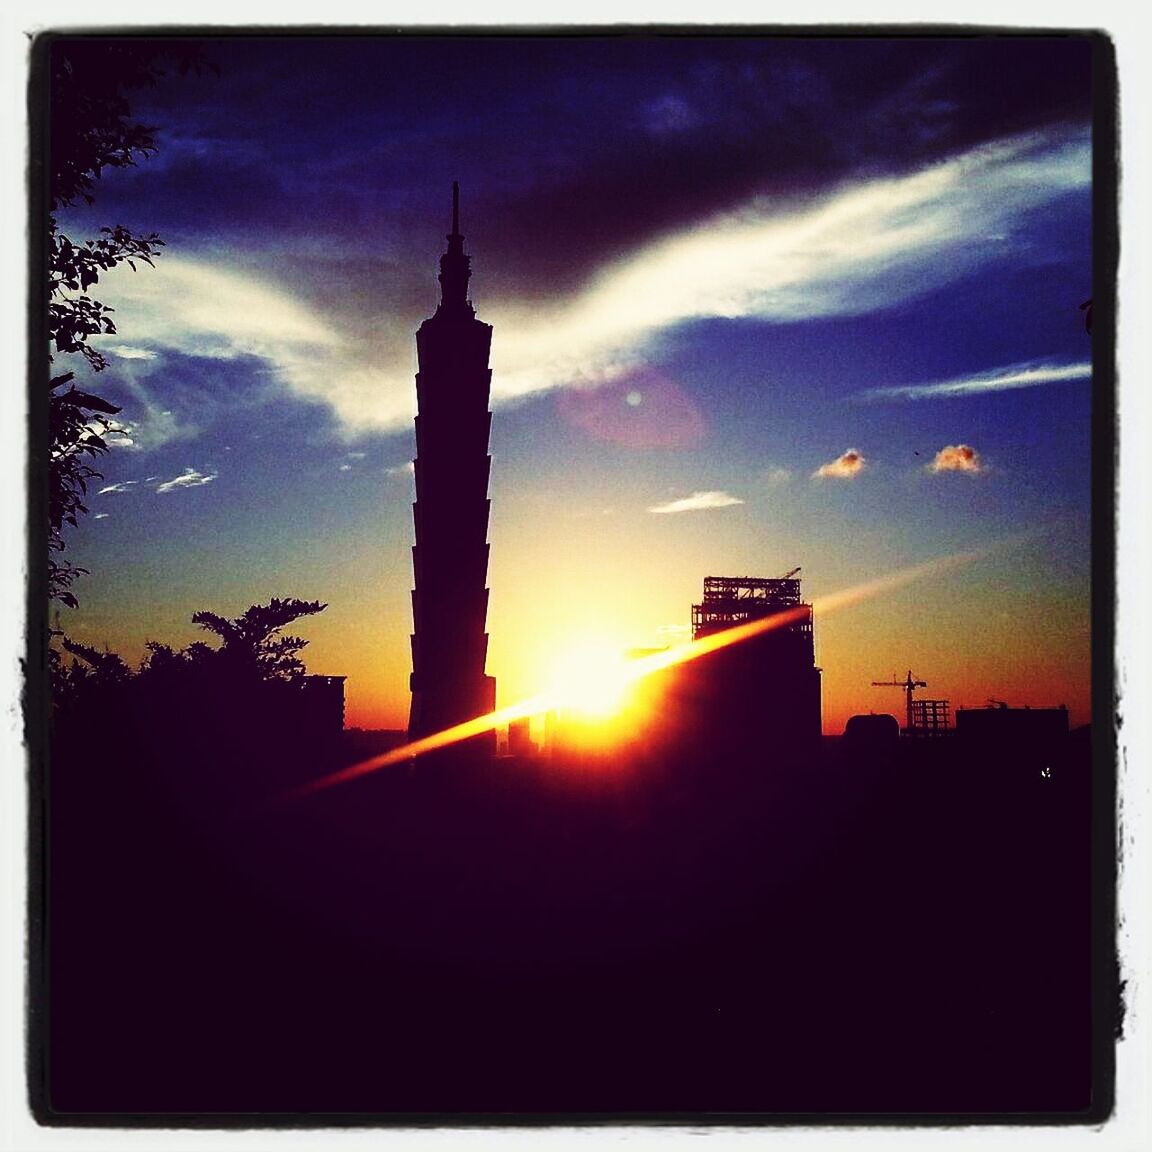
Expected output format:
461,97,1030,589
32,733,1093,1123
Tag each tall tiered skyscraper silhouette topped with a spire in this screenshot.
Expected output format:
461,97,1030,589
408,183,495,748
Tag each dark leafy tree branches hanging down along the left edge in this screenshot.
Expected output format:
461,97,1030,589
45,37,214,607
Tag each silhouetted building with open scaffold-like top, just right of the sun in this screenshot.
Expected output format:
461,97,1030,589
680,569,820,760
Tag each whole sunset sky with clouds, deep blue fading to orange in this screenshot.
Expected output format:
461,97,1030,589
51,36,1092,733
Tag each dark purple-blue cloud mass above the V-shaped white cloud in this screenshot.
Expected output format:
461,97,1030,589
67,36,1091,306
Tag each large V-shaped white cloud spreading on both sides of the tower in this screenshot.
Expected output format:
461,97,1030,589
92,124,1091,434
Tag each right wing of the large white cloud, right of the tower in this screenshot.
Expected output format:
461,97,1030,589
486,127,1091,396
